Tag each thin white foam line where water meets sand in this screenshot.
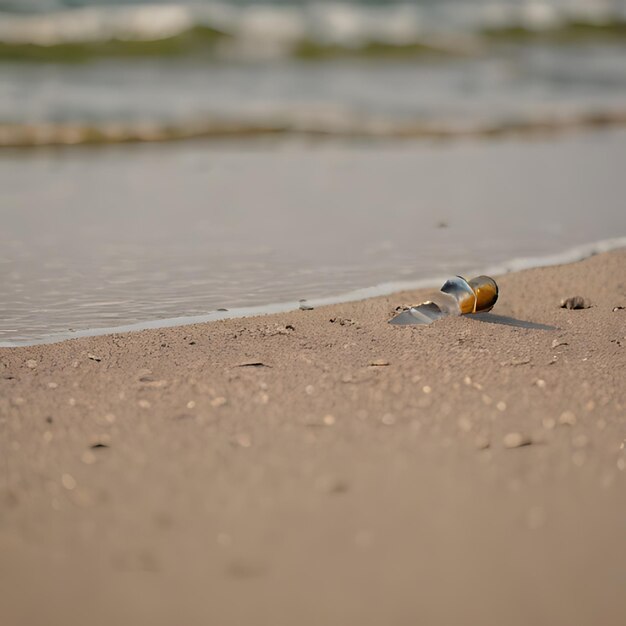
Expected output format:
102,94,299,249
0,237,626,349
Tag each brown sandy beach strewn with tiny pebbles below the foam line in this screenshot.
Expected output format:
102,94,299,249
0,250,626,626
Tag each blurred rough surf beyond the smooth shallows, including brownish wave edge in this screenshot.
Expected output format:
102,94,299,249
0,0,626,146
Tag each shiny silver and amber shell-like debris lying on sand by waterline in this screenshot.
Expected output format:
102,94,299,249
389,276,498,325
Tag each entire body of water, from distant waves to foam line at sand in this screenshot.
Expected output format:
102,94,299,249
0,0,626,343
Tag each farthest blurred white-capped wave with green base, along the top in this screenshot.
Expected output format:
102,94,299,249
0,0,626,62
